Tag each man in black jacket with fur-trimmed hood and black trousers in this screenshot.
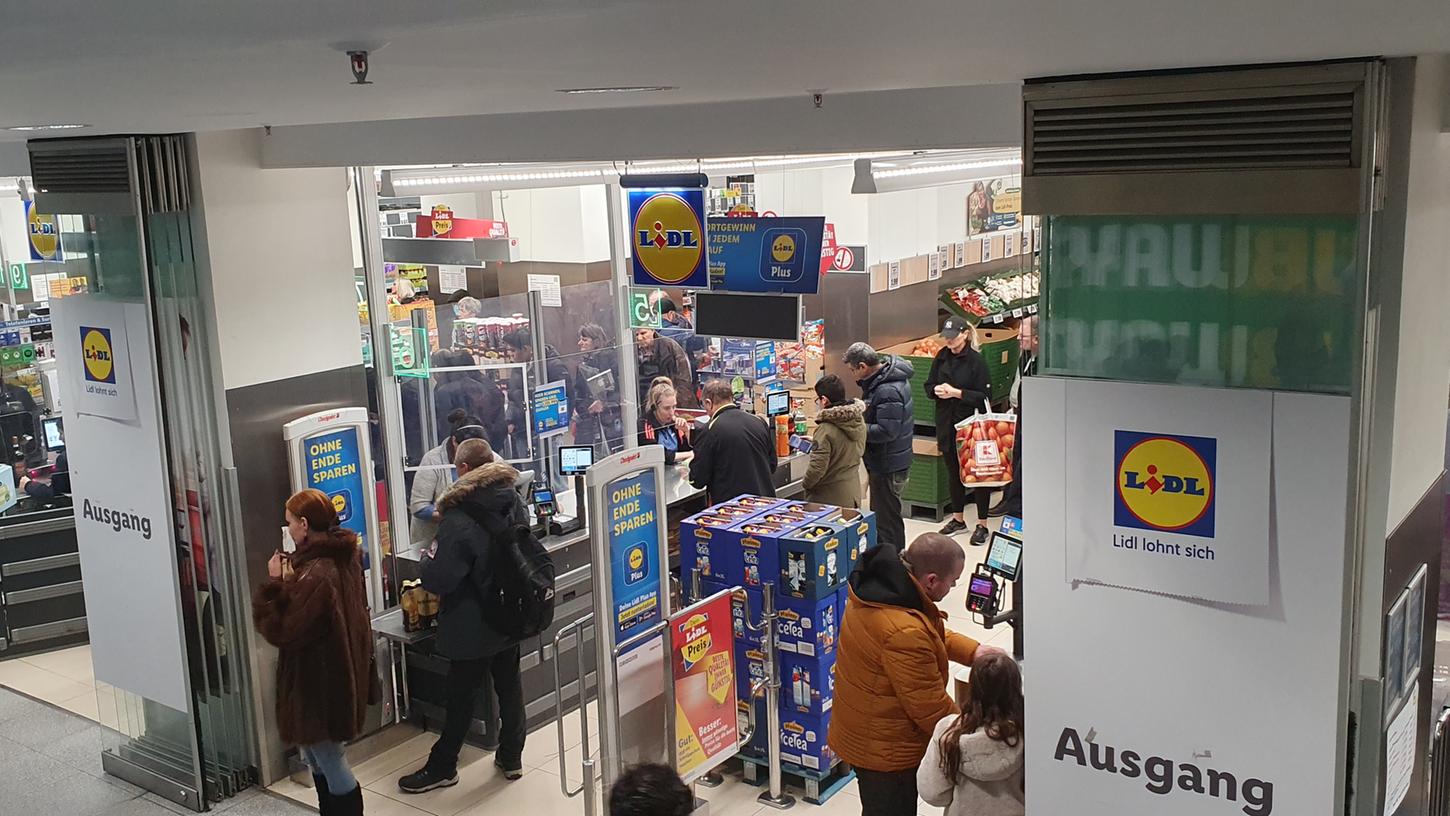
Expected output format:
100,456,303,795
397,439,528,793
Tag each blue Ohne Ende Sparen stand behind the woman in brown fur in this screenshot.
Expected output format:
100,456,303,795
281,407,383,609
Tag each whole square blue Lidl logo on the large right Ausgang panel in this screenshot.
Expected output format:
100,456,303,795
1112,430,1218,538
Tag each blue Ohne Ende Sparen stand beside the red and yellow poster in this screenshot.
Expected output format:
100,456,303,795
584,445,674,787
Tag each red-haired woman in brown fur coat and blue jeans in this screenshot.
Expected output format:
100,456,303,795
252,490,378,816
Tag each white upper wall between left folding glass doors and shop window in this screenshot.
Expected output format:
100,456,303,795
196,130,363,388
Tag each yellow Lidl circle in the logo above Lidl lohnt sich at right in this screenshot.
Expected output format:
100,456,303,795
1118,436,1214,530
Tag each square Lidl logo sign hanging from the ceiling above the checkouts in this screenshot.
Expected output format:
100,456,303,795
629,190,708,287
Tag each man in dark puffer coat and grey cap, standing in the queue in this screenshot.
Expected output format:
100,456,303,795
841,344,914,551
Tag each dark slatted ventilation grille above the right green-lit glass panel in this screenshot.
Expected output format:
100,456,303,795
1025,88,1357,175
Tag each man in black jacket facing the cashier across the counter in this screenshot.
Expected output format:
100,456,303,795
690,380,776,503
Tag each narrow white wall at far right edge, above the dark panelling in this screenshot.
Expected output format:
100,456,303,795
1386,55,1450,532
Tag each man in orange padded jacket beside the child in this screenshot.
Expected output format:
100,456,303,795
827,533,989,816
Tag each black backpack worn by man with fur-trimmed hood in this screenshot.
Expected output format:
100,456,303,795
463,504,554,641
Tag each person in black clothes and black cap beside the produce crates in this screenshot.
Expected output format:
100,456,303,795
925,317,992,546
